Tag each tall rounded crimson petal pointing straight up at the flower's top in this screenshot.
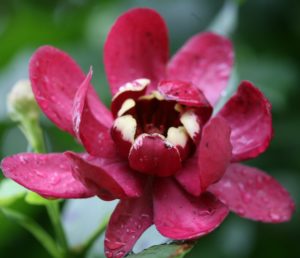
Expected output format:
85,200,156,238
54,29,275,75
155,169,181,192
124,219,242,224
104,8,169,94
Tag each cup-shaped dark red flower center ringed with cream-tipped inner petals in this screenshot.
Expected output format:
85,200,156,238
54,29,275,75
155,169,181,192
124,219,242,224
111,80,209,176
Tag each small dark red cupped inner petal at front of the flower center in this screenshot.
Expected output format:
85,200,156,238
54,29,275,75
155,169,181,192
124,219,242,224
128,134,181,176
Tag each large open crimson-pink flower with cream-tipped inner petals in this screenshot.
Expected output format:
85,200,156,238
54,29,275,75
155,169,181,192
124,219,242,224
1,8,294,257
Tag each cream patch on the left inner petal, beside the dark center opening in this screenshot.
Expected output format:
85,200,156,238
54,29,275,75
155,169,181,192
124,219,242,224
114,115,137,143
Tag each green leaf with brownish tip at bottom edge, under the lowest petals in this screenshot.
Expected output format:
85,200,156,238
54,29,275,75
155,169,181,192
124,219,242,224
127,242,195,258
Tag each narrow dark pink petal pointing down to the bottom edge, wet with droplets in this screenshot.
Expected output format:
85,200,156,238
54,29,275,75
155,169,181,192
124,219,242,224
104,187,153,258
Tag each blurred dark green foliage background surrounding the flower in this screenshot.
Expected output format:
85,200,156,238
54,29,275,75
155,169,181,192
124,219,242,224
0,0,300,258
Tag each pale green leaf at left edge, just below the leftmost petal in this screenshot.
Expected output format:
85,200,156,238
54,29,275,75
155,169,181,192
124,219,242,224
0,178,28,207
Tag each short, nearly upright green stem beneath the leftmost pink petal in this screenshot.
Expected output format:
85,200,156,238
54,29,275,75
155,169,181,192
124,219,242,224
46,201,69,255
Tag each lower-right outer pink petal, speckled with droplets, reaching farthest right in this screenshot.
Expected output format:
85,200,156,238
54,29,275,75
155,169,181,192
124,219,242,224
208,164,295,223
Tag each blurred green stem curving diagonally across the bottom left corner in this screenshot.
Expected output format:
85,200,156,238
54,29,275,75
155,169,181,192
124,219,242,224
0,207,63,258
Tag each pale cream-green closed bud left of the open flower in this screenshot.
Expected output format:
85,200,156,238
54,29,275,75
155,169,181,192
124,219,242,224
7,80,39,121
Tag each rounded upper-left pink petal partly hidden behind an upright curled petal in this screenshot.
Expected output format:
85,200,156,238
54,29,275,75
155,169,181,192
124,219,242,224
29,46,112,135
